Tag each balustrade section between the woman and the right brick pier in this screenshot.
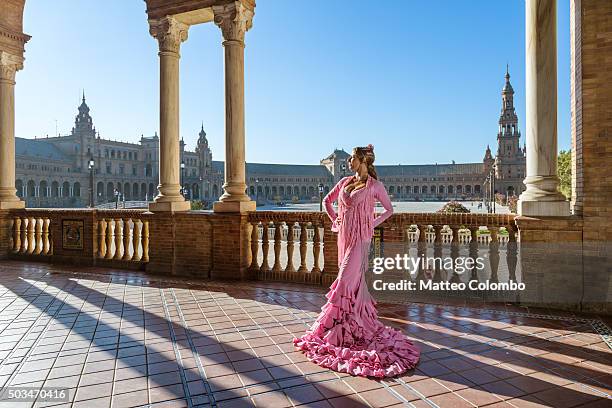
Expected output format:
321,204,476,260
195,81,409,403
367,213,522,298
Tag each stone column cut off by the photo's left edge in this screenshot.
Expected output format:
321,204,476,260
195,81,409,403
0,51,25,210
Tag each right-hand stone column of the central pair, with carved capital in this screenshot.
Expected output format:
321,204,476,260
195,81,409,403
213,1,255,212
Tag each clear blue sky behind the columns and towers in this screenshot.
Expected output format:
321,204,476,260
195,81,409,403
16,0,571,164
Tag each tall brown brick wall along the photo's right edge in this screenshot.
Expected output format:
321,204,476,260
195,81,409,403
571,0,612,310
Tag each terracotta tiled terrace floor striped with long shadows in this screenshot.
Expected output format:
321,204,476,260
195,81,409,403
0,261,612,408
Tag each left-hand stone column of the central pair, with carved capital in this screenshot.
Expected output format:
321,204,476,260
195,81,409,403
149,16,191,212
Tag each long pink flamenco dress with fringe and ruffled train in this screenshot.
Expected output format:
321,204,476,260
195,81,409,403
293,176,420,378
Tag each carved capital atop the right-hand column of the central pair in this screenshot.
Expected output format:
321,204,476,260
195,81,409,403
212,1,255,46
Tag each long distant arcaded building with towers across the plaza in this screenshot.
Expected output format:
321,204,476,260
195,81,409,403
16,71,526,207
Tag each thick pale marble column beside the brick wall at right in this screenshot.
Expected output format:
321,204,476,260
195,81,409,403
518,0,569,216
